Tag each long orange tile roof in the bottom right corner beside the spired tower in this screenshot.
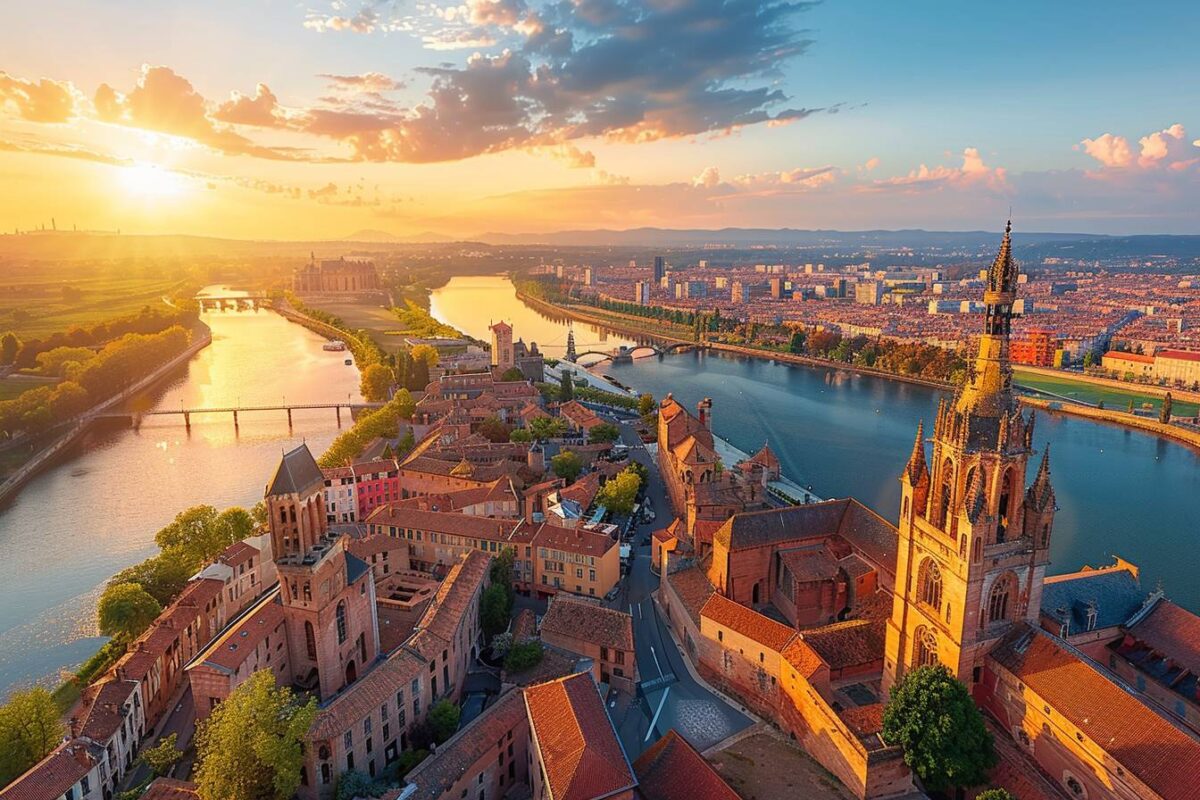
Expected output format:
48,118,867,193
989,625,1200,800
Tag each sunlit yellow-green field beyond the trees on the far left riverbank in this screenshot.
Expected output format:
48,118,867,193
0,276,180,339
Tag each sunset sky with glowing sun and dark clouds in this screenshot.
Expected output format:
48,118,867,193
0,0,1200,239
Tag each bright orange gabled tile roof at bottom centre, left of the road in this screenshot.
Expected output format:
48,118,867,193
524,672,637,800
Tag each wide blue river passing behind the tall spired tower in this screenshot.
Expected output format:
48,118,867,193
431,276,1200,612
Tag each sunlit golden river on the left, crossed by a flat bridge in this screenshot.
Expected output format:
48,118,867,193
0,287,360,699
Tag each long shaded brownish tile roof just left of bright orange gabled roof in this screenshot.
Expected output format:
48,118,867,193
406,690,527,800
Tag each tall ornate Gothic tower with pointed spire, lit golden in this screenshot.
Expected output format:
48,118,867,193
883,223,1054,692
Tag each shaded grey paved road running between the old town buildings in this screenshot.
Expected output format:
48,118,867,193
612,425,752,759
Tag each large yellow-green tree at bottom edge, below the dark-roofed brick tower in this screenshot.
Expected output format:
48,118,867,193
196,669,317,800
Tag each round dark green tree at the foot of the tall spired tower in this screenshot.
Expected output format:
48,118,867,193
882,664,996,792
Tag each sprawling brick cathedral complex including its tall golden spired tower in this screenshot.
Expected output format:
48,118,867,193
655,224,1200,800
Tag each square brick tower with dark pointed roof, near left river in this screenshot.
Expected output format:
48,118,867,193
264,445,379,698
